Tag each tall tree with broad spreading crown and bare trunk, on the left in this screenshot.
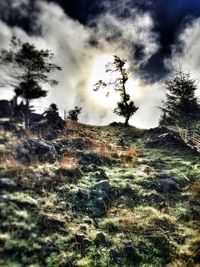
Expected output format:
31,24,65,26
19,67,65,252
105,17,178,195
0,37,61,129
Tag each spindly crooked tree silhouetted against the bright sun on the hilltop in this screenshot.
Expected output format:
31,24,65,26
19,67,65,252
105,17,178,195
94,55,138,126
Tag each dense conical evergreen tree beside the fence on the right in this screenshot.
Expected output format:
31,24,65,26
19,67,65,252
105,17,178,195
160,70,200,128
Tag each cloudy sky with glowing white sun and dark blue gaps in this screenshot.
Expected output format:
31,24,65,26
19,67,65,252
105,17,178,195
0,0,200,128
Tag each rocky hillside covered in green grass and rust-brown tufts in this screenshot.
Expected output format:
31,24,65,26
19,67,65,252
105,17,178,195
0,122,200,267
